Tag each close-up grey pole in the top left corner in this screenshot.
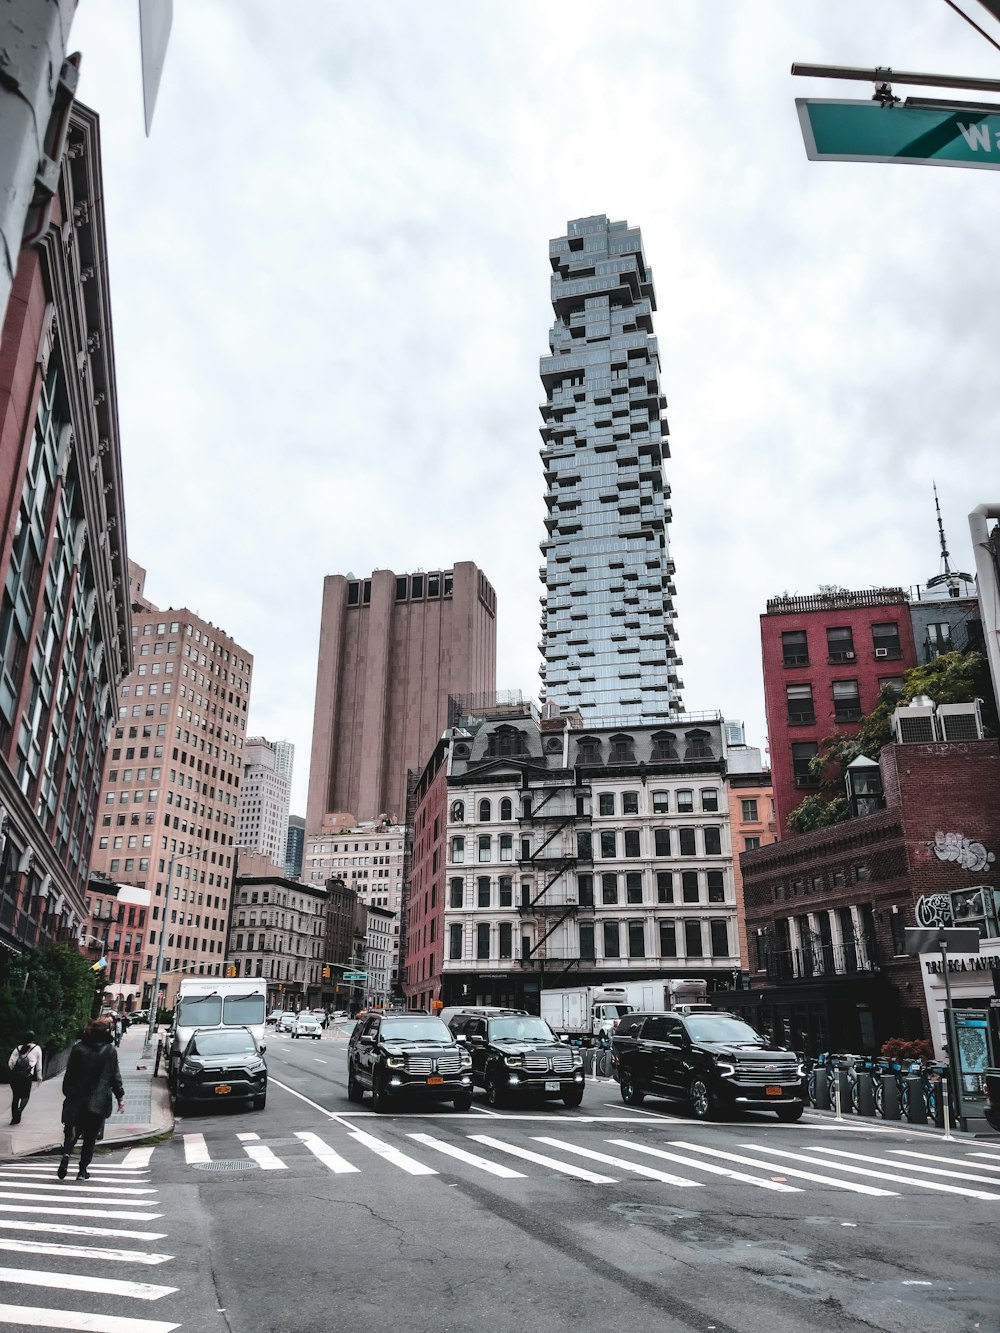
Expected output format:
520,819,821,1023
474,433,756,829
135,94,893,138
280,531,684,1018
0,0,77,325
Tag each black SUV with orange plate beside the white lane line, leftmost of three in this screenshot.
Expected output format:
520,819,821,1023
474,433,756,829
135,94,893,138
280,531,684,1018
347,1013,472,1112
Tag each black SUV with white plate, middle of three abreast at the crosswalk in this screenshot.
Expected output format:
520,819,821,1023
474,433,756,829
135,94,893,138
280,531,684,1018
451,1010,584,1106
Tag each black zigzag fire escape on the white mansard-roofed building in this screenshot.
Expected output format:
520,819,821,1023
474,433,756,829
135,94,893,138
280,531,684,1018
517,782,593,976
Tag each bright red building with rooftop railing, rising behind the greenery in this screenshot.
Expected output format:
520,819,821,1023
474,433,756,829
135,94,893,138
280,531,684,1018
760,588,917,837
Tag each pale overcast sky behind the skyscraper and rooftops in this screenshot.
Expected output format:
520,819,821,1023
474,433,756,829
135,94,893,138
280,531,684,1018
72,0,1000,812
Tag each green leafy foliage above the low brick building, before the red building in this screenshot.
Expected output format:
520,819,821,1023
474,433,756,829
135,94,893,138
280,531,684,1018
788,652,997,833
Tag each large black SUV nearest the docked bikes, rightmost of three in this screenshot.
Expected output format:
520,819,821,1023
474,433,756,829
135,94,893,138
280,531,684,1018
611,1009,804,1121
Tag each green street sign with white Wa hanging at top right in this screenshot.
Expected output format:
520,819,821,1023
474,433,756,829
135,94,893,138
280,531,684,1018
795,97,1000,171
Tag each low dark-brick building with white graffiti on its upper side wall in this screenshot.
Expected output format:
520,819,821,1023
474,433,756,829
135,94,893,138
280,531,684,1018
735,714,1000,1057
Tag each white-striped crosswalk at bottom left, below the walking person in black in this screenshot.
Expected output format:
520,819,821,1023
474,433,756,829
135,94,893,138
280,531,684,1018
0,1148,180,1333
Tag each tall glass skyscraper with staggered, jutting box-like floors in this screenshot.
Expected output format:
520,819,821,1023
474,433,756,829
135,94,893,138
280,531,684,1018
539,215,681,725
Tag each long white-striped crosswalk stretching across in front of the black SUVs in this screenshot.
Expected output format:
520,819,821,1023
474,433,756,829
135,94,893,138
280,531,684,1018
170,1122,1000,1204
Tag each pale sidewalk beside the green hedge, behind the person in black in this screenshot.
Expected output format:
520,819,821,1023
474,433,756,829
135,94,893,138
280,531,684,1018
0,1026,173,1161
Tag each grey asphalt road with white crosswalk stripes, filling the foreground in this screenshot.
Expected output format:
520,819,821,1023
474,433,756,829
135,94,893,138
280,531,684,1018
0,1033,1000,1333
